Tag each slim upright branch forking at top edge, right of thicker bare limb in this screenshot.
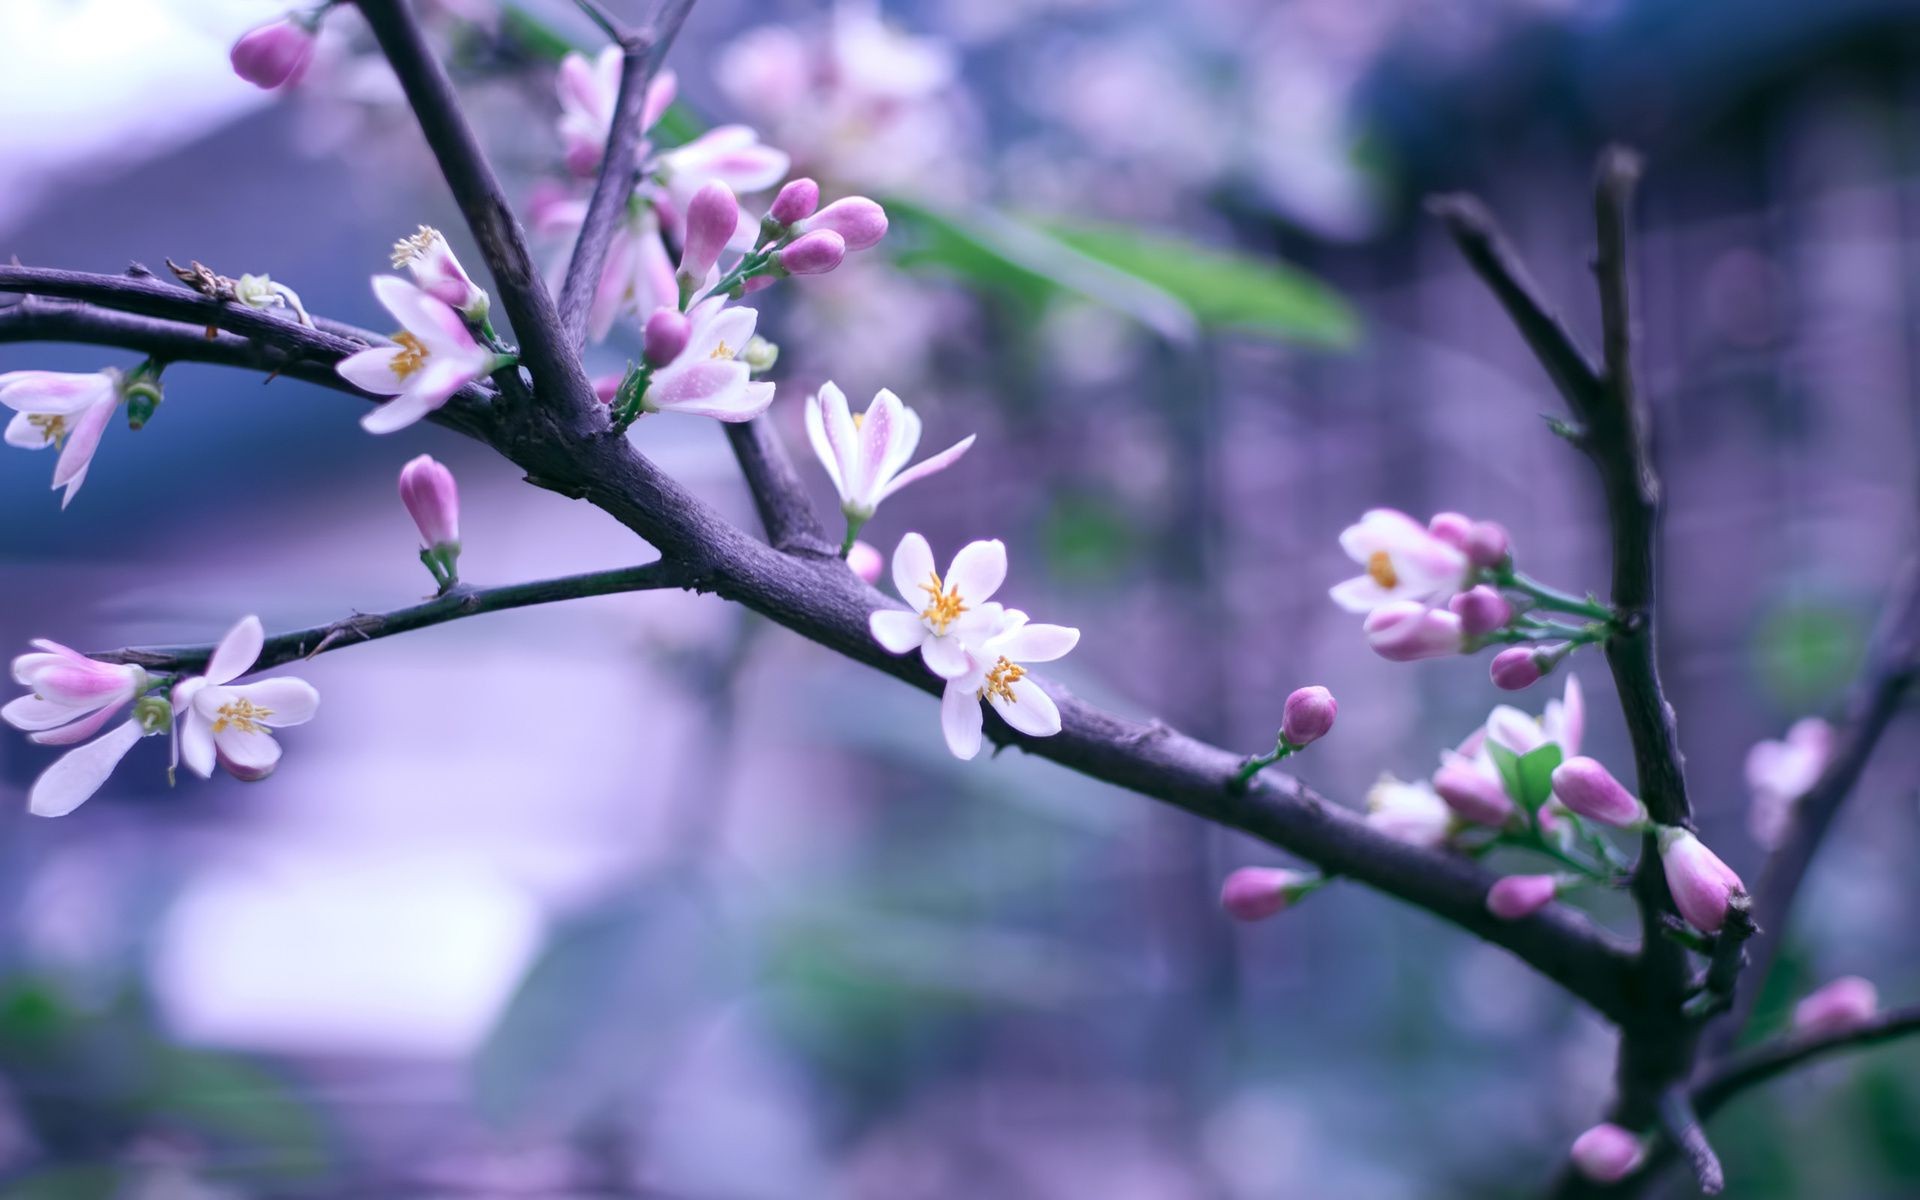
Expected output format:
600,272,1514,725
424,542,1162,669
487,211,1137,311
561,0,693,349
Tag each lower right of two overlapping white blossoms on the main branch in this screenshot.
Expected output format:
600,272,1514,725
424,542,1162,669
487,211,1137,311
933,606,1079,758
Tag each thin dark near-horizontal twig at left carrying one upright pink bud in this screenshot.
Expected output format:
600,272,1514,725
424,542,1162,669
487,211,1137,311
92,559,695,672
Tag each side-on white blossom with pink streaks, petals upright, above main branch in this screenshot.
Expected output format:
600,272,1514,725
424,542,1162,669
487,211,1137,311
806,382,973,522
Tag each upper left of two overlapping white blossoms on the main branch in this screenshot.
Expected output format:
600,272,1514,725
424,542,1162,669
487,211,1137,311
868,534,1013,679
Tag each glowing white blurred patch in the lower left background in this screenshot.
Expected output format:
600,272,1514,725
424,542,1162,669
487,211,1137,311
154,851,541,1058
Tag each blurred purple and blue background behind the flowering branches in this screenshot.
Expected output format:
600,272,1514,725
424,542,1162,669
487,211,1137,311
0,0,1920,1200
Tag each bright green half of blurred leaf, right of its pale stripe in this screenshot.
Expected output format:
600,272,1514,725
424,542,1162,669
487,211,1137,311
1048,221,1359,349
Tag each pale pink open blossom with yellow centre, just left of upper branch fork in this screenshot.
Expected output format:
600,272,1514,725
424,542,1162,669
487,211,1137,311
334,275,497,434
